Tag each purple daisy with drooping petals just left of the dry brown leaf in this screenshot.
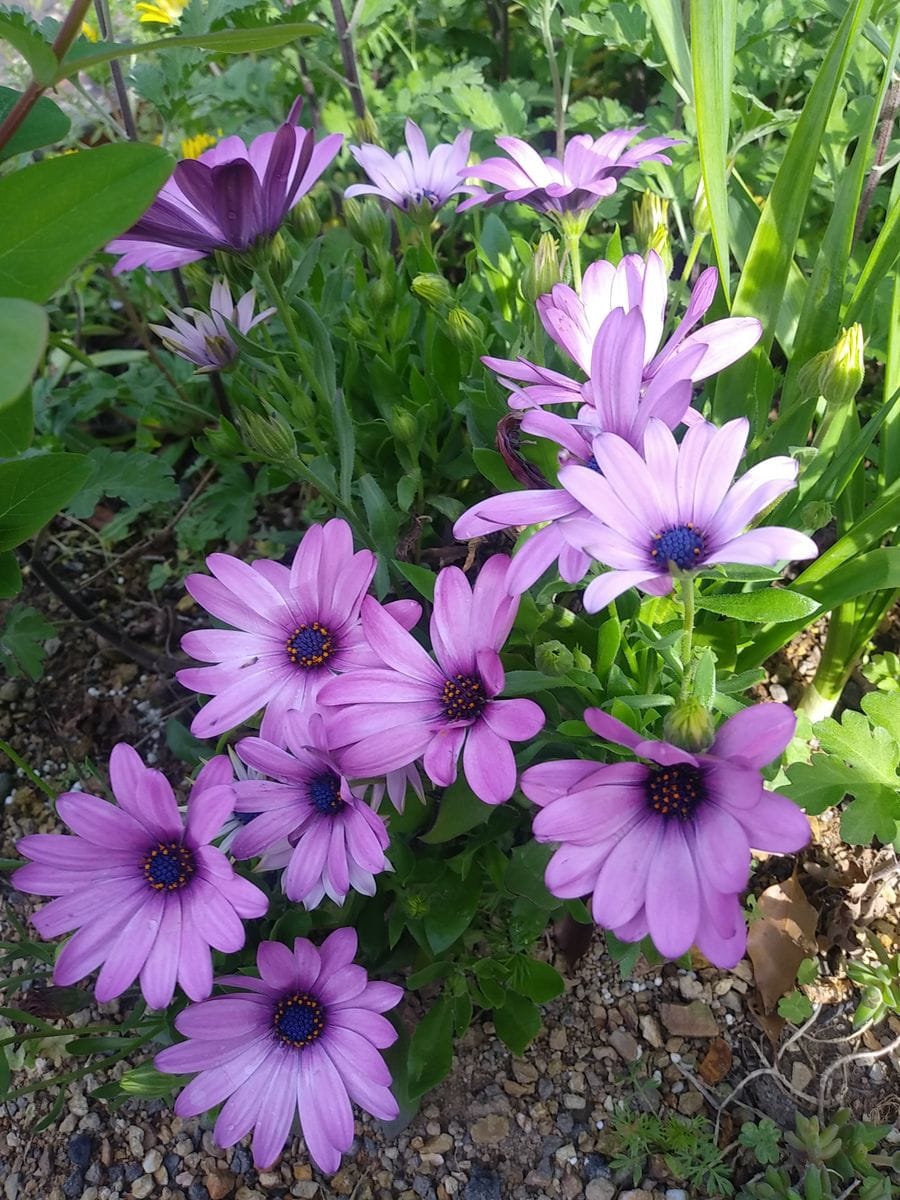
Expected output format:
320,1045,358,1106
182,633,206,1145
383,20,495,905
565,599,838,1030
521,704,810,967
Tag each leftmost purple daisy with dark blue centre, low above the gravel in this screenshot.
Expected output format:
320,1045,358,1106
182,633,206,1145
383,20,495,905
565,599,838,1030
12,743,268,1008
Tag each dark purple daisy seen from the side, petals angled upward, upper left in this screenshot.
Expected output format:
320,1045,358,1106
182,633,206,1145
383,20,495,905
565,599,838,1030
106,100,343,275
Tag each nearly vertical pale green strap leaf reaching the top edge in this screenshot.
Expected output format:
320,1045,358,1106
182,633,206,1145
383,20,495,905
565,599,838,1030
690,0,737,301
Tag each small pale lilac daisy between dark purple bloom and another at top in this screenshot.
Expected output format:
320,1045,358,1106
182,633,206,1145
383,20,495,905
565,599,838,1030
344,120,475,212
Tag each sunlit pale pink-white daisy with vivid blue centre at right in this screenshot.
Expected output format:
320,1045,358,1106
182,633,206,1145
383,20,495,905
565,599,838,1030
559,416,818,612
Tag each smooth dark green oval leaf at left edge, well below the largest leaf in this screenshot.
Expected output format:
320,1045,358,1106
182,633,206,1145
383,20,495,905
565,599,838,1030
0,454,90,551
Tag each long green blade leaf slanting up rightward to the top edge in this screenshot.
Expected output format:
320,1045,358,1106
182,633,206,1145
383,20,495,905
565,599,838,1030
716,0,872,424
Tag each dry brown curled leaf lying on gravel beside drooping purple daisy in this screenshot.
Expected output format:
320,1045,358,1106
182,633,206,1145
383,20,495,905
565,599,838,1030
746,875,818,1013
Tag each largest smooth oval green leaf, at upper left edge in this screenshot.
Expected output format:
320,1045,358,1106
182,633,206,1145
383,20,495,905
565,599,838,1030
0,143,174,304
